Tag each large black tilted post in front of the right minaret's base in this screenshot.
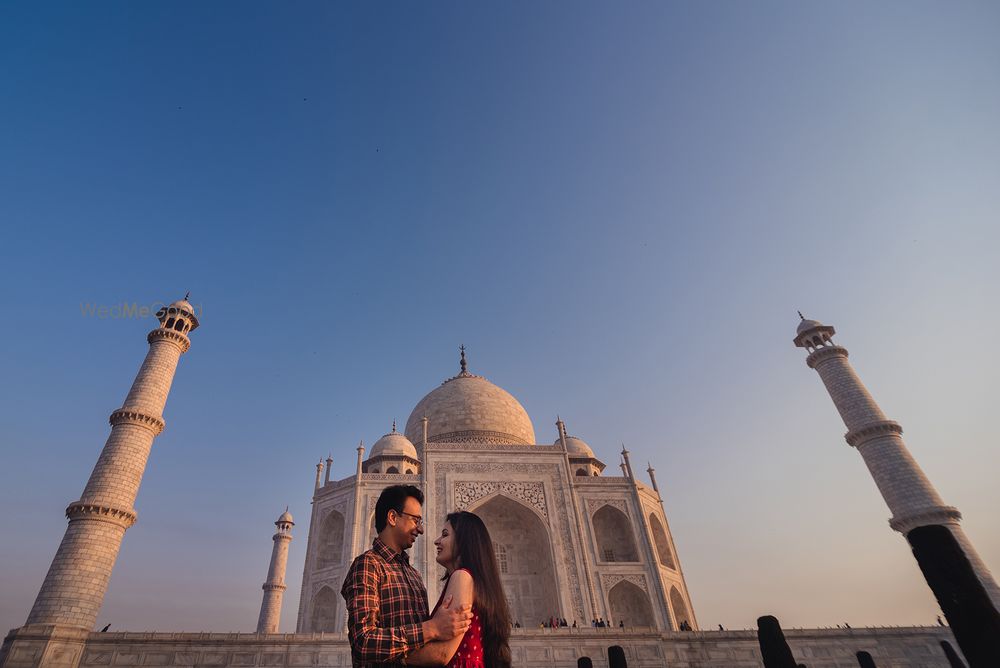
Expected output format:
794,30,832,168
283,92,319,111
906,524,1000,668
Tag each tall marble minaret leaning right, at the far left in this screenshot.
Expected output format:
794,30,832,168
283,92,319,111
28,297,198,630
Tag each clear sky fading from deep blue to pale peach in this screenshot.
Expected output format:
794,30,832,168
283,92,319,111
0,0,1000,631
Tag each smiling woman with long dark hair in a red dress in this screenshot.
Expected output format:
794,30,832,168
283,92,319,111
406,511,511,668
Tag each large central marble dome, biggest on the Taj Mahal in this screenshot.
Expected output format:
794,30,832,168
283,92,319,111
406,366,535,445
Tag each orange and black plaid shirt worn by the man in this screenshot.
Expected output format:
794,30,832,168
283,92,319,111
340,538,430,668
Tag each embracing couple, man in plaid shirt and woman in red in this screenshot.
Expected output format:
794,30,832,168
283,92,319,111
341,485,511,668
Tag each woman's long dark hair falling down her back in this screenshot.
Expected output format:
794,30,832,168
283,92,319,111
446,511,510,668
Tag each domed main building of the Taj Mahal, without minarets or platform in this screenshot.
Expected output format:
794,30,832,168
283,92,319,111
297,348,697,633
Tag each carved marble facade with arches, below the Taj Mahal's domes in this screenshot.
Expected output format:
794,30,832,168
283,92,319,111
297,443,696,633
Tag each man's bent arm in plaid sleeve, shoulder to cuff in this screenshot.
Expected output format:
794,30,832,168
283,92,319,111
341,553,427,663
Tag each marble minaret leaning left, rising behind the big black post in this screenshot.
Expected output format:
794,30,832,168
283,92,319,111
794,313,1000,608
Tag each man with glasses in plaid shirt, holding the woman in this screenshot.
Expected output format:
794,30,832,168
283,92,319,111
340,485,472,668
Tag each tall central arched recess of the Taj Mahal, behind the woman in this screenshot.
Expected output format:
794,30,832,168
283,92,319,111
472,496,561,628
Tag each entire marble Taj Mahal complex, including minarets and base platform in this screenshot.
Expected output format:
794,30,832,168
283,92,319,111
0,298,1000,668
